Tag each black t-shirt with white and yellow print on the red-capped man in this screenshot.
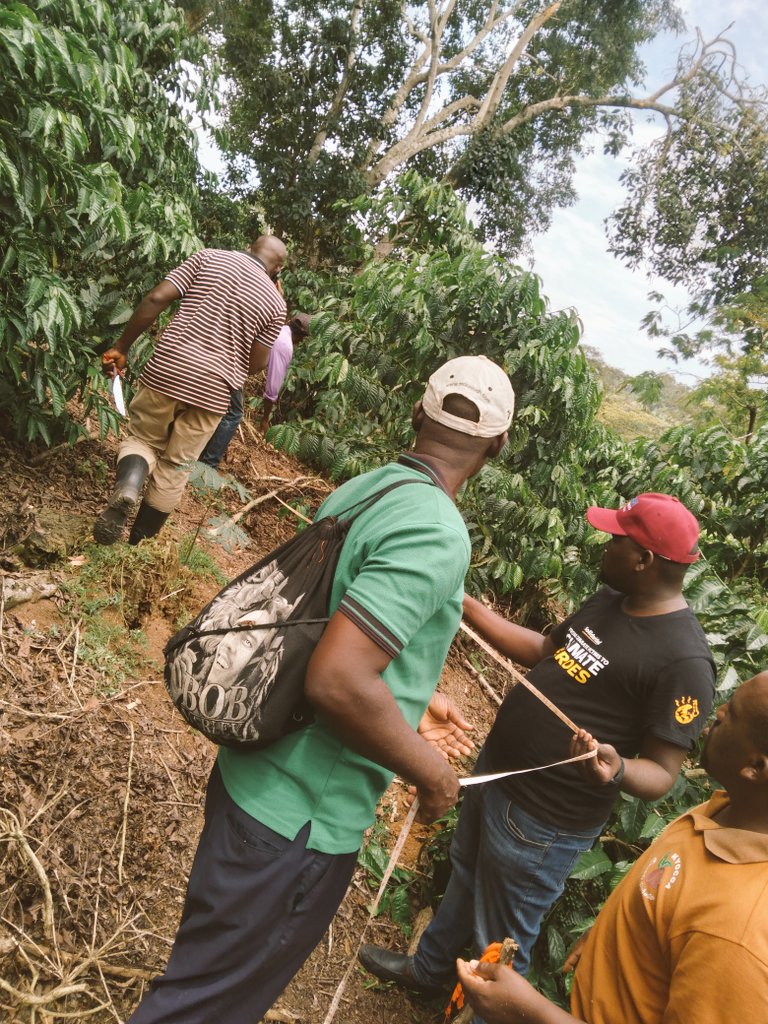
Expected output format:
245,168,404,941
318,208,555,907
485,587,715,830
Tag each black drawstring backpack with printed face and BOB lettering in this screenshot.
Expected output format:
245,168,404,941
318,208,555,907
164,479,432,750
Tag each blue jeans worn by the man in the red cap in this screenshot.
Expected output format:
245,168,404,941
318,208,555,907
414,761,601,1007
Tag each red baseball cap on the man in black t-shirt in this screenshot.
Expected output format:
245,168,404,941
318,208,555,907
587,494,701,562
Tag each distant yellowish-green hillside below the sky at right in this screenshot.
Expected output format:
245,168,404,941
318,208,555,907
583,345,690,440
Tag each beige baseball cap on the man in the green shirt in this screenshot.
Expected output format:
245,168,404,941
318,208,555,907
423,355,515,437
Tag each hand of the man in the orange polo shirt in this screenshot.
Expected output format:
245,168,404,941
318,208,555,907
456,959,550,1024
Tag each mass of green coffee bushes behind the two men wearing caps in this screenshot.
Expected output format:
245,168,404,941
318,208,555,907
268,174,768,999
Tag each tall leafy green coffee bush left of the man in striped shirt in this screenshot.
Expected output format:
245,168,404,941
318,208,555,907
0,0,208,444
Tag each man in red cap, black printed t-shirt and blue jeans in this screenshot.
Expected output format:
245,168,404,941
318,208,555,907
360,494,715,1011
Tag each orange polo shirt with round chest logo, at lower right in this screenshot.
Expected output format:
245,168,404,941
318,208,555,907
571,791,768,1024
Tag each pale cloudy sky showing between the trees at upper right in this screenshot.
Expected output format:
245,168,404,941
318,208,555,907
523,0,768,385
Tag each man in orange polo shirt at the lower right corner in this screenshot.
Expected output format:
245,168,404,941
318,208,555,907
458,672,768,1024
